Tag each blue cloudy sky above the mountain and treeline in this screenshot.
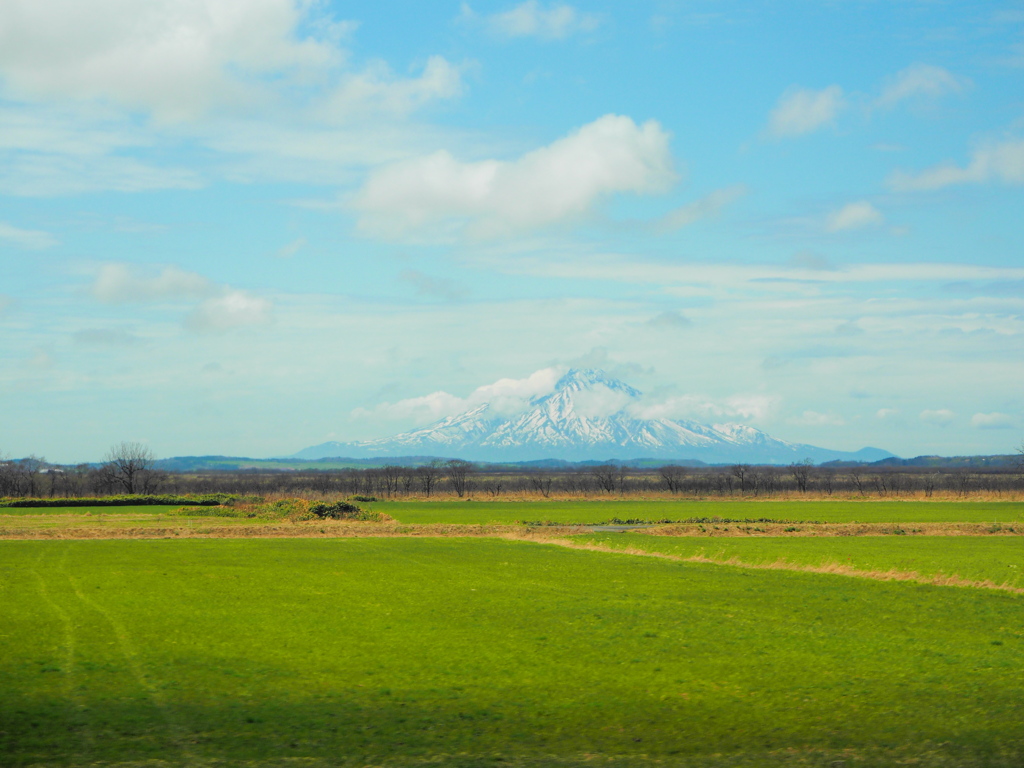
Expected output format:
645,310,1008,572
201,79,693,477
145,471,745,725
0,0,1024,463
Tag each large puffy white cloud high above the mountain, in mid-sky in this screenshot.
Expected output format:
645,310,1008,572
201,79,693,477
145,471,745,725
353,115,676,237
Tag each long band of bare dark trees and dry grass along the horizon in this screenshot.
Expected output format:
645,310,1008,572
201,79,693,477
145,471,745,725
0,442,1024,499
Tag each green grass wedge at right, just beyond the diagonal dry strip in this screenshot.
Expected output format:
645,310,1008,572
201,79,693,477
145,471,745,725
572,532,1024,587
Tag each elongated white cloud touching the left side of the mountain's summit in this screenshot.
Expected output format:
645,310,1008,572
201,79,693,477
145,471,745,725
352,367,566,423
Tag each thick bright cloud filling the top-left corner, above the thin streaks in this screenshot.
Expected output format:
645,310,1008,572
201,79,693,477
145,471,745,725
0,0,348,120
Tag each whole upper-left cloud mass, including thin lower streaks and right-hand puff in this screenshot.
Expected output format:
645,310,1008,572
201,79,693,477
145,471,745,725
0,0,465,196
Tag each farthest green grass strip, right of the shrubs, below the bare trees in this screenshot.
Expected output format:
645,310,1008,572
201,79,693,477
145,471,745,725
372,500,1024,523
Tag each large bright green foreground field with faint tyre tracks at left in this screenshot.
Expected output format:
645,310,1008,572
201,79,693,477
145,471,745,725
0,539,1024,768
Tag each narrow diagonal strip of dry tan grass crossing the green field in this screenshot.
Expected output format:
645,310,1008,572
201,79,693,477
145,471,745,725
532,539,1024,595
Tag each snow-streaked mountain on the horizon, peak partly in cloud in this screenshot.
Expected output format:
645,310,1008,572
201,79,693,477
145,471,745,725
293,369,891,464
